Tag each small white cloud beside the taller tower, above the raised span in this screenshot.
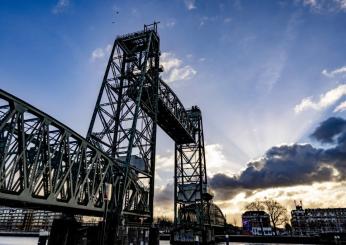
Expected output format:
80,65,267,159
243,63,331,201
160,52,197,83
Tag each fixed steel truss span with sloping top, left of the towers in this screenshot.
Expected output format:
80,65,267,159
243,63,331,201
0,90,121,215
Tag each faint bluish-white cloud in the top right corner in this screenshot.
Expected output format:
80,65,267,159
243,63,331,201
297,0,346,13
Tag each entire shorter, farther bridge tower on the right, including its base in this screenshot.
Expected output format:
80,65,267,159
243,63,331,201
173,106,212,242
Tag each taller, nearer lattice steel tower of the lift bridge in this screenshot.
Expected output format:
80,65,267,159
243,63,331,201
87,23,160,243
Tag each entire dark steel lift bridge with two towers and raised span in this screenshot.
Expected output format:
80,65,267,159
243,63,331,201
0,23,225,244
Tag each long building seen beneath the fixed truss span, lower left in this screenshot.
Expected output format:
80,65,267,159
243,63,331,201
0,207,60,232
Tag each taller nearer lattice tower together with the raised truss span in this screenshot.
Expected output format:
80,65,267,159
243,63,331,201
87,23,200,228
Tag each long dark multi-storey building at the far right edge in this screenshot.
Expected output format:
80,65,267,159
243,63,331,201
291,202,346,236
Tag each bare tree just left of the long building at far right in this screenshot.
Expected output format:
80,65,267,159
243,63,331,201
263,199,288,236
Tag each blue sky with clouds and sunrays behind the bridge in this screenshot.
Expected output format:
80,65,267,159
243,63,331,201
0,0,346,225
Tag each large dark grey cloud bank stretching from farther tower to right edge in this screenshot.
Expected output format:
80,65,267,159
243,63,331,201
209,118,346,199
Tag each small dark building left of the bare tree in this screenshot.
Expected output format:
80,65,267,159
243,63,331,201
241,211,273,236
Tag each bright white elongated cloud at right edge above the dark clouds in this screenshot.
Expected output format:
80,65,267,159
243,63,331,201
294,84,346,113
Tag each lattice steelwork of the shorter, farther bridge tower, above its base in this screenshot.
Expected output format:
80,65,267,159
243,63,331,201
174,106,208,226
